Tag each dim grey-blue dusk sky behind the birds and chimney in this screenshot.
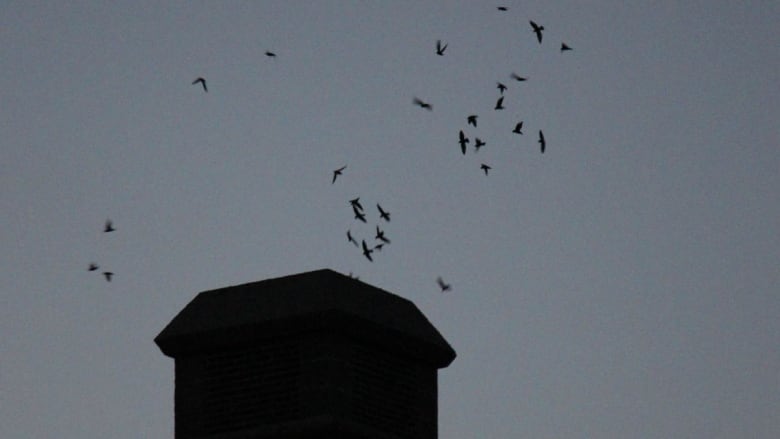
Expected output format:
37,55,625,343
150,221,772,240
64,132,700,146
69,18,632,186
0,0,780,439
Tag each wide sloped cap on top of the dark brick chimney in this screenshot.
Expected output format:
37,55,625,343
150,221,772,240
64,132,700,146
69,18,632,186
154,269,455,368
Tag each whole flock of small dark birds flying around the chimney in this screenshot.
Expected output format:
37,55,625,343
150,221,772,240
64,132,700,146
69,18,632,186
87,6,572,292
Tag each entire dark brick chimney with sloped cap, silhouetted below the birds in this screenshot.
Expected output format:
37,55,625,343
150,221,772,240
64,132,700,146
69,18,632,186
154,269,455,439
